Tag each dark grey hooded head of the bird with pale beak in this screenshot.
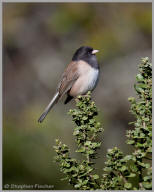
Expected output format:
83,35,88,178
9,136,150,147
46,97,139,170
72,46,98,68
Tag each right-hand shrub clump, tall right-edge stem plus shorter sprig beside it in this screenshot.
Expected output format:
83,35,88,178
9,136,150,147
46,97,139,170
101,57,152,190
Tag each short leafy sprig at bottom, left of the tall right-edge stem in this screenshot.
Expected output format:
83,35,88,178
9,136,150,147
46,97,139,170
101,147,137,190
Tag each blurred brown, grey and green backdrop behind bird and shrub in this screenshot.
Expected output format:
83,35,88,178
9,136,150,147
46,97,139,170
3,3,152,190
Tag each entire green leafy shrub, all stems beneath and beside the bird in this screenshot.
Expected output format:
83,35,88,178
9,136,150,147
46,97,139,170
54,57,152,190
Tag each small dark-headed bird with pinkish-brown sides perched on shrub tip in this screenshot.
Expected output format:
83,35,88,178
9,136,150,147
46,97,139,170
38,46,100,123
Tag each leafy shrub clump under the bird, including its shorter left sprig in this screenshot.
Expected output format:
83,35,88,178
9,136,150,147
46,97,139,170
54,92,102,190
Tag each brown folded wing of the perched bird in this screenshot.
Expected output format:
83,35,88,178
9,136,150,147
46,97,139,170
58,61,79,97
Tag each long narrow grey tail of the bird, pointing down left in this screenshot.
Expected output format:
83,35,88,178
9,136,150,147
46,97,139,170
38,92,60,123
